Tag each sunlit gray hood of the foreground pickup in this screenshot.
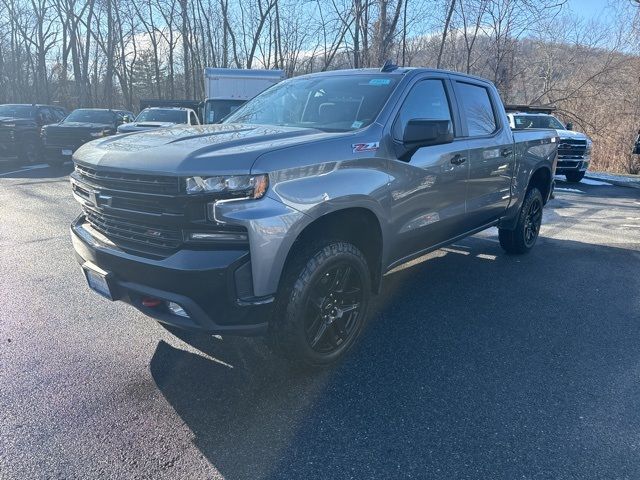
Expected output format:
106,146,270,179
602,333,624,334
73,124,345,176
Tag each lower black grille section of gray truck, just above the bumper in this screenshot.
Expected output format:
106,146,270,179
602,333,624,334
84,206,182,257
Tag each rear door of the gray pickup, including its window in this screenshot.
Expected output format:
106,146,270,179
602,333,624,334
453,78,515,228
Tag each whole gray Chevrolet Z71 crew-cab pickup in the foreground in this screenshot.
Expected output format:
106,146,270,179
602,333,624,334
71,67,557,366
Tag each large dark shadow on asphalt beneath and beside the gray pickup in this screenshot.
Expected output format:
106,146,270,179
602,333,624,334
150,237,640,480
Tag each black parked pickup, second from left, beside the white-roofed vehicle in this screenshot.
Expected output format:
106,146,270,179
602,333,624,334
41,108,133,166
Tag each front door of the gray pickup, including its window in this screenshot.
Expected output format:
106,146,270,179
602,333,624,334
390,78,469,261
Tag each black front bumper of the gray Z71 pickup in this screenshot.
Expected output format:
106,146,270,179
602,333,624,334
71,215,273,336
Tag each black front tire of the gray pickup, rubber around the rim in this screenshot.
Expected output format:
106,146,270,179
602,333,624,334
267,240,371,368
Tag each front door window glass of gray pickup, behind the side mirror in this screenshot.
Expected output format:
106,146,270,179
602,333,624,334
394,80,451,140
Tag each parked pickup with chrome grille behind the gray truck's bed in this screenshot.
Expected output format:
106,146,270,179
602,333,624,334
507,111,593,183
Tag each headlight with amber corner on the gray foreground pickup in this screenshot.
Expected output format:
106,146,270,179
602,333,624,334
185,175,269,198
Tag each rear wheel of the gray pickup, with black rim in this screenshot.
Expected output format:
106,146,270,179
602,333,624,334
498,187,543,253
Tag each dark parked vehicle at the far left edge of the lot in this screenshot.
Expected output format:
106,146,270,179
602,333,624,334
0,104,67,163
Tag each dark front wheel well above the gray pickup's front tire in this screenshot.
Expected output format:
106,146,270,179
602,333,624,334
284,208,382,292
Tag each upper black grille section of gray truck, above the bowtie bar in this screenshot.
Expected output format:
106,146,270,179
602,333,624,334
76,165,180,195
